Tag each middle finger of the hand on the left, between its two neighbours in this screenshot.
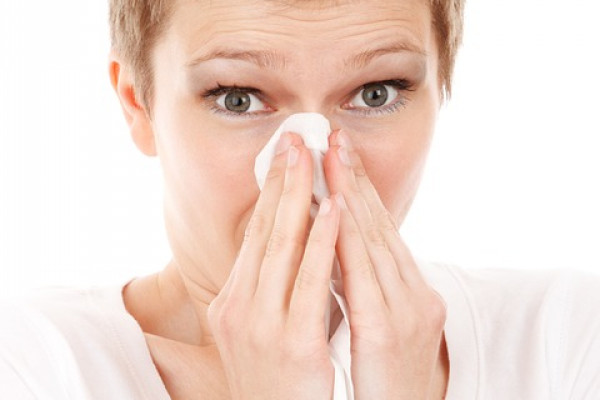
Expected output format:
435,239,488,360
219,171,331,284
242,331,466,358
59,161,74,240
255,145,313,311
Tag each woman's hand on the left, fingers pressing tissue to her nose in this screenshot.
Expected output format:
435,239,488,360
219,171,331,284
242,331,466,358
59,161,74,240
208,133,340,400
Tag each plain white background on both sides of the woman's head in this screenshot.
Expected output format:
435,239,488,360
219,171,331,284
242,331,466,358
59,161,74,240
0,0,600,295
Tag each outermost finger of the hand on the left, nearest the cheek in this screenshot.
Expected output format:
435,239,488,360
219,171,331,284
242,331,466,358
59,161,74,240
229,133,302,296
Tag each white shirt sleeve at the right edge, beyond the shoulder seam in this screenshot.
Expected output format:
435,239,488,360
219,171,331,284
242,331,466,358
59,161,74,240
547,272,600,400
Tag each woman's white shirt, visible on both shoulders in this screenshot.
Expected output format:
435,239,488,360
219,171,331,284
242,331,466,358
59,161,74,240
0,262,600,400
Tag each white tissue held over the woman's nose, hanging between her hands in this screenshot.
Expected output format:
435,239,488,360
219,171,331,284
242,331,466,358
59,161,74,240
254,113,354,400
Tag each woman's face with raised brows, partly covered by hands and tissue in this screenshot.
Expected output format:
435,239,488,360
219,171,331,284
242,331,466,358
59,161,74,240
149,0,440,287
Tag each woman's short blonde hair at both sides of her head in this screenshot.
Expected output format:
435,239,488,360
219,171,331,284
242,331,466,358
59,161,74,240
109,0,465,116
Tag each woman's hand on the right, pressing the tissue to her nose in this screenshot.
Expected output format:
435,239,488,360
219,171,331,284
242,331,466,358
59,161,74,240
325,132,446,400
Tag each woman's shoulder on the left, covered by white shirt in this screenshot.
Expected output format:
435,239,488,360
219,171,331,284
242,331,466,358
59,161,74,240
0,286,166,398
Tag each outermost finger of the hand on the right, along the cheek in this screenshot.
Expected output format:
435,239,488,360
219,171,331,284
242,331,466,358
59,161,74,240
332,131,426,288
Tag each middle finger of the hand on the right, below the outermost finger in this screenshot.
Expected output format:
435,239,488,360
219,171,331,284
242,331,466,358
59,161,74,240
327,146,407,306
